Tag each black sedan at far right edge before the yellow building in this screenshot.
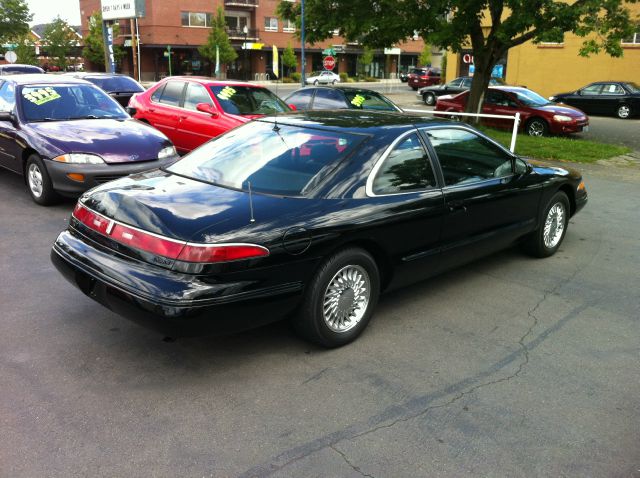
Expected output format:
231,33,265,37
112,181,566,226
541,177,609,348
549,81,640,119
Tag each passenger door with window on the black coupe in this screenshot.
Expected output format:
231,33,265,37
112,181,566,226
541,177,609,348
421,126,541,263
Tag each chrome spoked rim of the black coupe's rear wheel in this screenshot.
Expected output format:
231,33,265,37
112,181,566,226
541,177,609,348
322,265,371,332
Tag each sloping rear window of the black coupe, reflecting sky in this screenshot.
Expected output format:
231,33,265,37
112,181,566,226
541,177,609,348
168,121,362,196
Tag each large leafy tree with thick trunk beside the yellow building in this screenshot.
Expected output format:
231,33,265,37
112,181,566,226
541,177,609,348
278,0,637,112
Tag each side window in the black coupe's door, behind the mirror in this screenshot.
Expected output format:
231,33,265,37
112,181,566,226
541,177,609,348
425,128,513,186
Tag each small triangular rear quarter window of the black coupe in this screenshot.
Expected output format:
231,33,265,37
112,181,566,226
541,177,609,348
372,133,436,195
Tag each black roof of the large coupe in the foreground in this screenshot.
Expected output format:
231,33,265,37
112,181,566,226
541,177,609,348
255,109,450,134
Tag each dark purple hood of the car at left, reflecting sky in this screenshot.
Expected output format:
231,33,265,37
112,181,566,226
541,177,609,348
25,119,169,163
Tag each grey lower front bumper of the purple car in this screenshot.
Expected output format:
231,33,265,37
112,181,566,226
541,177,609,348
45,157,176,196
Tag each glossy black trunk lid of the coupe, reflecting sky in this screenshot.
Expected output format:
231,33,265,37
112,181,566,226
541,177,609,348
81,170,316,244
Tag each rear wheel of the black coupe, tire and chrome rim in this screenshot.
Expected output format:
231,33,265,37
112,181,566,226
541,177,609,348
293,248,380,348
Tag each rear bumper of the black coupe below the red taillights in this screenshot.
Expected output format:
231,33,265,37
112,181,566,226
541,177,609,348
51,231,302,337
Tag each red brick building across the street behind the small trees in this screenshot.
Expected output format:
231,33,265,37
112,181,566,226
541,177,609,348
79,0,432,81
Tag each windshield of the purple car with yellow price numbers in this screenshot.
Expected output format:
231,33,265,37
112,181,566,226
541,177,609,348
20,84,129,121
